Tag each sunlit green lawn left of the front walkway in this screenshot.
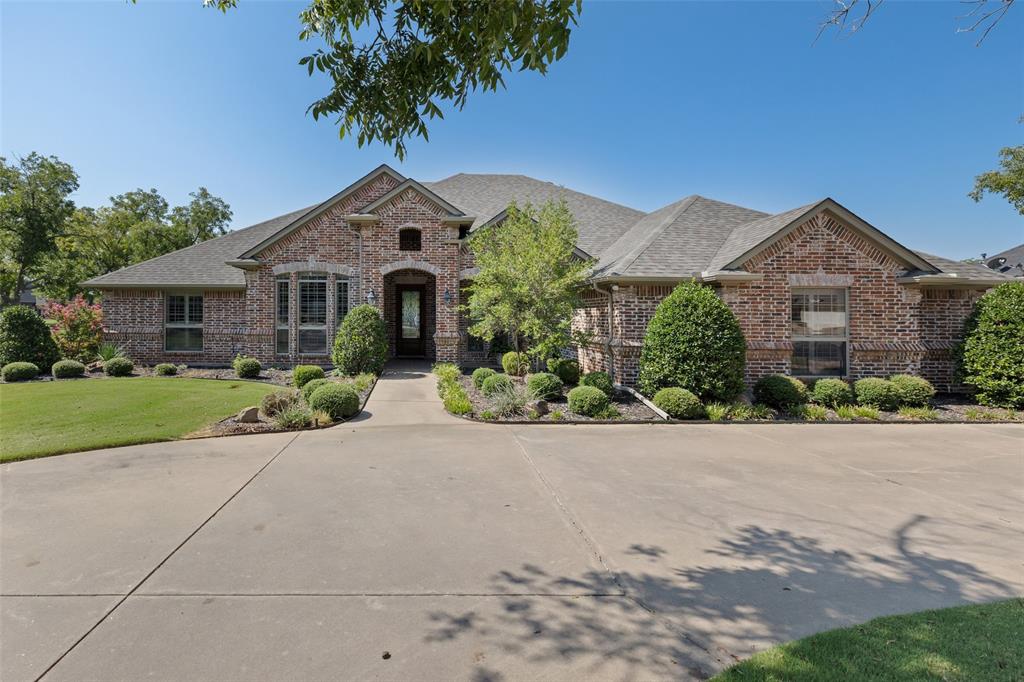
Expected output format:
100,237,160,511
0,377,278,461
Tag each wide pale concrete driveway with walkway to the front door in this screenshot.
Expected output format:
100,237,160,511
6,372,1024,681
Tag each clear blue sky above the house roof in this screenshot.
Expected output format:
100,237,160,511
0,0,1024,258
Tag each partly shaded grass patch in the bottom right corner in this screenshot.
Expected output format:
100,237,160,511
714,599,1024,682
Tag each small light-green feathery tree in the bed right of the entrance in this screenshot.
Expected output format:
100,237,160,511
463,201,592,360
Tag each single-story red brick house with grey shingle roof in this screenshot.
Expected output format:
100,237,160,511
84,161,1009,387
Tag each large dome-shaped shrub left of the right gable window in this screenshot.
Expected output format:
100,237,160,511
639,282,746,401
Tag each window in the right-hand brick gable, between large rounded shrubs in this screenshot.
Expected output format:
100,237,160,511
792,289,849,377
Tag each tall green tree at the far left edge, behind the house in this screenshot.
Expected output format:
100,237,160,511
0,152,78,307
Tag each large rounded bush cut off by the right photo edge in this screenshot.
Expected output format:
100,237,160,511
956,282,1024,410
